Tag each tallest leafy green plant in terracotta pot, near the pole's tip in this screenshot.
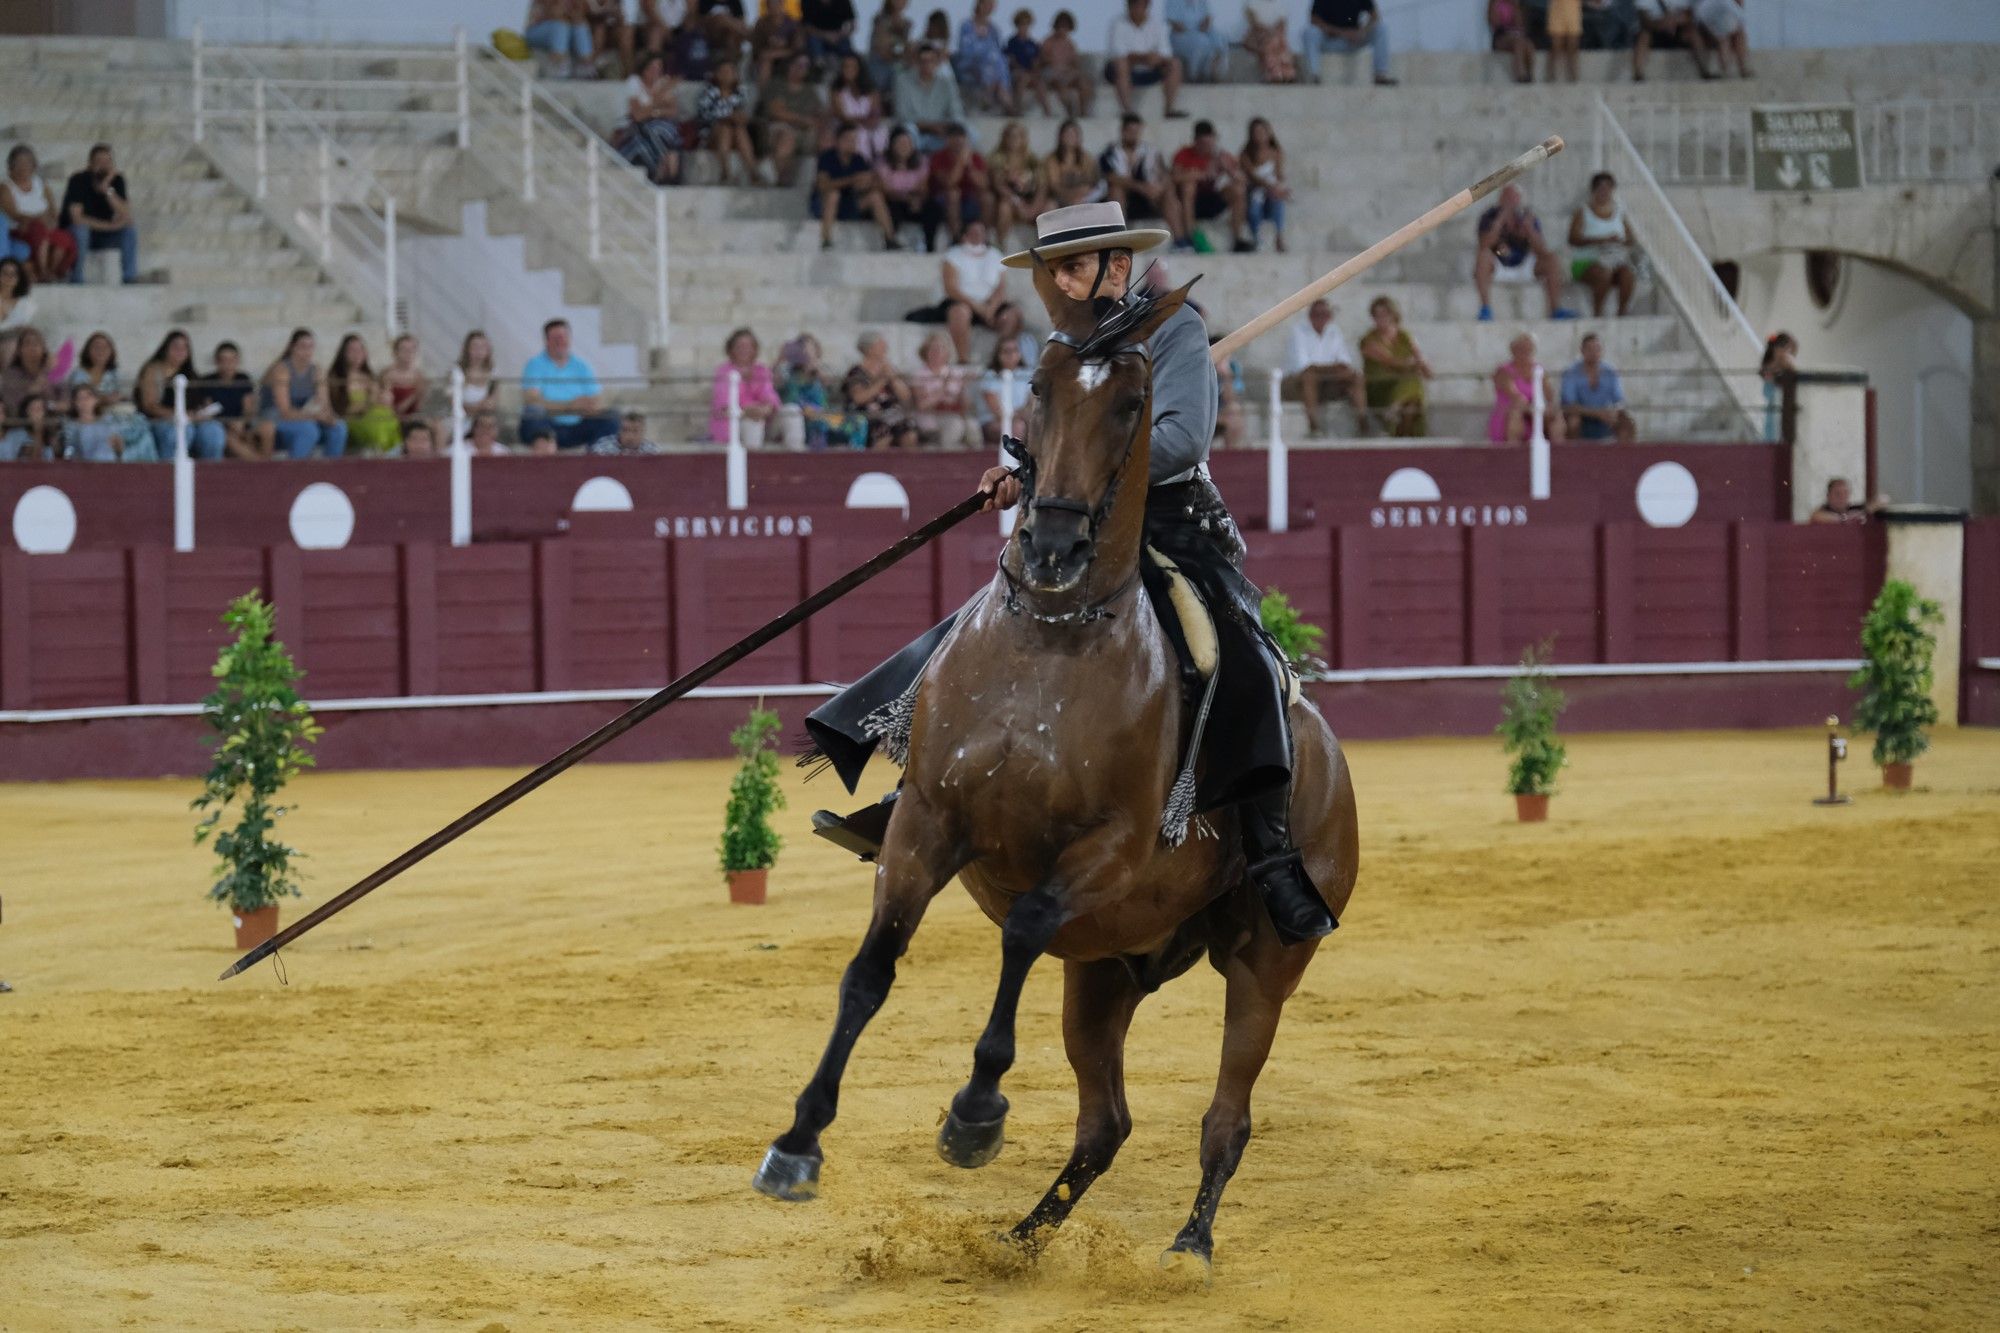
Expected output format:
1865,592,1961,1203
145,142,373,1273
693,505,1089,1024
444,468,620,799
194,590,320,949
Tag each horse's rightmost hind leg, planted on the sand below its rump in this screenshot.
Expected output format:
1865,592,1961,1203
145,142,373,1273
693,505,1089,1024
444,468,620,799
1160,907,1316,1269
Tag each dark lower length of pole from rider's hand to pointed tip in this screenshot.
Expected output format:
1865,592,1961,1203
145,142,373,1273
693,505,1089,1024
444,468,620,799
220,490,986,981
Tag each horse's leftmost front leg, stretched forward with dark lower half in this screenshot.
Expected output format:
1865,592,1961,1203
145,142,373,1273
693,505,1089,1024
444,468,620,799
750,793,960,1203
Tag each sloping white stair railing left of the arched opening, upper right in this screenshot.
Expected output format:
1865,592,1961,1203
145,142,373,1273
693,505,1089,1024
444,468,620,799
1592,98,1764,436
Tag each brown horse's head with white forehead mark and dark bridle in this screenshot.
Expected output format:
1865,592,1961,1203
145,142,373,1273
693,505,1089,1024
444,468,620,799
1014,258,1194,592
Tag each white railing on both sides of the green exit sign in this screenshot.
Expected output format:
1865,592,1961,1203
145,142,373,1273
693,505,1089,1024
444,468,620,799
1622,98,2000,186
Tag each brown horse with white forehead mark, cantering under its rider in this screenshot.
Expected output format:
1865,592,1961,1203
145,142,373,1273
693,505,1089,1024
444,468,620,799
754,266,1358,1267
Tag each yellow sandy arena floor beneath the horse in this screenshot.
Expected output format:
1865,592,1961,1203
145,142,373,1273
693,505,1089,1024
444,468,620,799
0,733,2000,1331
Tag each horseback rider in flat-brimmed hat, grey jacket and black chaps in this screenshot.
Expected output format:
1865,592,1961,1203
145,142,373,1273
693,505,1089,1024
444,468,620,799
806,202,1338,943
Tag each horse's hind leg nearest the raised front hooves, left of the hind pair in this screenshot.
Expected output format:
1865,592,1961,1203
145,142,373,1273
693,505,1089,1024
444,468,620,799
1012,959,1146,1251
